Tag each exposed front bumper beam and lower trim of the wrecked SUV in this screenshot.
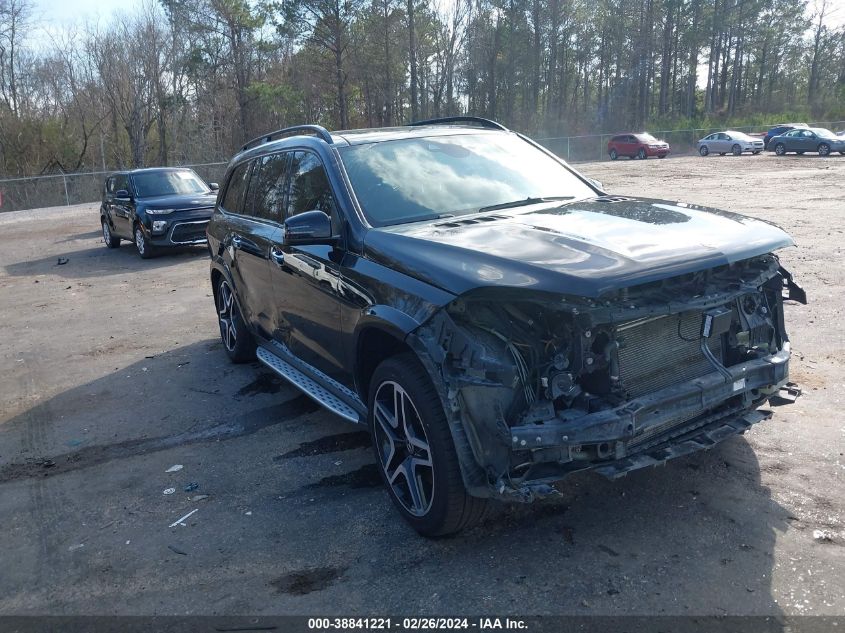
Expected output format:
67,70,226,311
502,343,789,494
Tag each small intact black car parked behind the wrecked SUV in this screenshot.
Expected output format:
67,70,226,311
100,167,218,259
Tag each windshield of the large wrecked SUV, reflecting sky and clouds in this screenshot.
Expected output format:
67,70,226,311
339,134,596,226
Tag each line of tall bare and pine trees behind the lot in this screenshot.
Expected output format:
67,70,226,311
0,0,845,176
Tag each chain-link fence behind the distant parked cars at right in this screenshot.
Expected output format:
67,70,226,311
535,121,845,163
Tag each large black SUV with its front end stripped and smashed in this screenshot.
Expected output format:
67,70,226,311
208,117,806,535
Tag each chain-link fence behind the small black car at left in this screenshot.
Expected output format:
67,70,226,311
0,163,227,212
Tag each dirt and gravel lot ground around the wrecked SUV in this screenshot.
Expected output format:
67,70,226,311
0,156,845,615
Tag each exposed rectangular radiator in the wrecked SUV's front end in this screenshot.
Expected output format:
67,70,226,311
616,311,722,398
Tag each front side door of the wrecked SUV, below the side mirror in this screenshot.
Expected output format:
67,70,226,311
270,151,349,384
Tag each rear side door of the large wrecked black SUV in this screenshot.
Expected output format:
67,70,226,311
221,159,276,336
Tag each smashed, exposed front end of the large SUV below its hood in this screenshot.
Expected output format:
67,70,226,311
414,254,806,500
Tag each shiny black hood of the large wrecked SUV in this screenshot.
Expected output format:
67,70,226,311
365,196,793,297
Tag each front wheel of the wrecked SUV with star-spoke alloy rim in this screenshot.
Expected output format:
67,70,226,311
368,353,488,536
